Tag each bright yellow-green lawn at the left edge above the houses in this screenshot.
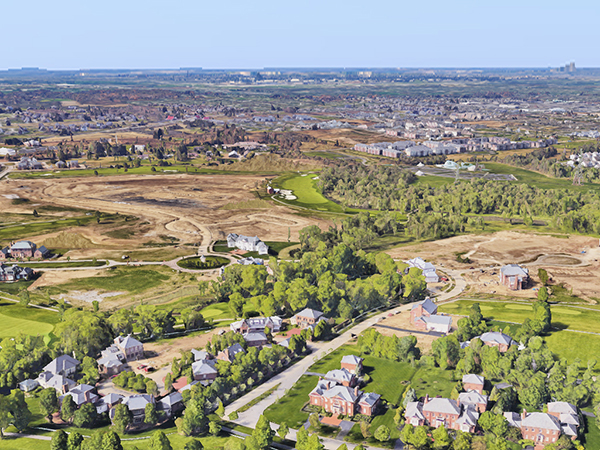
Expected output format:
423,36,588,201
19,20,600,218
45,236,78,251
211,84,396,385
0,301,60,339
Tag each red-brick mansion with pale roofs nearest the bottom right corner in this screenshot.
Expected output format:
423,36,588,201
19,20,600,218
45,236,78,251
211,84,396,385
504,402,579,450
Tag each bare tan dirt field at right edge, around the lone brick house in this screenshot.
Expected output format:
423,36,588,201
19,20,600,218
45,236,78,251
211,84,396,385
387,231,600,299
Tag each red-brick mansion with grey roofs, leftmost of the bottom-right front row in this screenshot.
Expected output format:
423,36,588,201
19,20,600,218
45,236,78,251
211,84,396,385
309,380,381,416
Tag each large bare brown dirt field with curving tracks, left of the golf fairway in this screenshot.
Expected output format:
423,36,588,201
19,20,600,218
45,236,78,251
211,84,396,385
0,175,328,257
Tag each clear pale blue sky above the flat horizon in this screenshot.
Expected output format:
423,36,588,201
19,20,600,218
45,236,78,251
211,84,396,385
0,0,600,69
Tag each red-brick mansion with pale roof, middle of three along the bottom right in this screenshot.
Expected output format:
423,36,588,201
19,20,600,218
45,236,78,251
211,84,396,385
404,396,479,433
